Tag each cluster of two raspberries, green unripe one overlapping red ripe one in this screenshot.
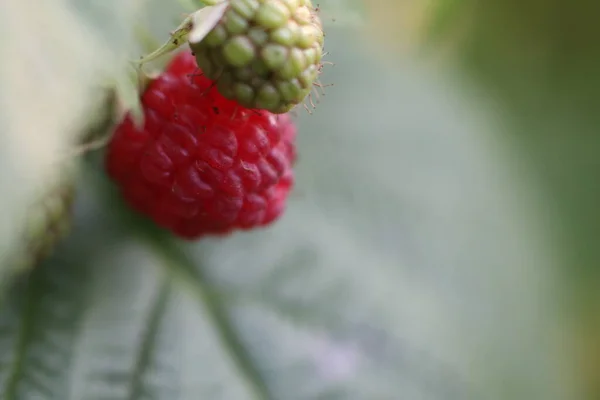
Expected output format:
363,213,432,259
106,0,324,239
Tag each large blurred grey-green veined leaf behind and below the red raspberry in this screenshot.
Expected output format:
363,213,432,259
0,23,580,400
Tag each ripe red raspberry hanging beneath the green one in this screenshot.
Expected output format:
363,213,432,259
106,52,296,239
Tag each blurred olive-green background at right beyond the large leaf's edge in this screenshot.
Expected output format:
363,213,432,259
360,0,600,398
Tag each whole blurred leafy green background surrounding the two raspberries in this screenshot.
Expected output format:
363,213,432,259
0,0,600,400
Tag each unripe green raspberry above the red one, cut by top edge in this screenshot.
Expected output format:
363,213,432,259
190,0,324,114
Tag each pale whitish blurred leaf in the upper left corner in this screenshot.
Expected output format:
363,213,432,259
0,0,155,284
